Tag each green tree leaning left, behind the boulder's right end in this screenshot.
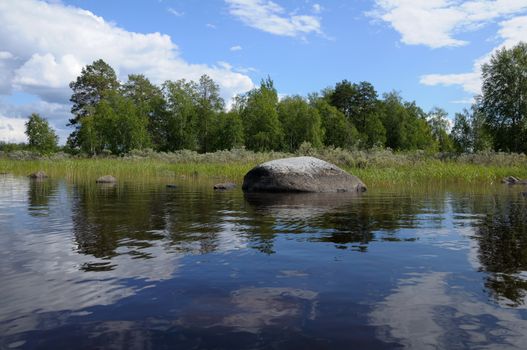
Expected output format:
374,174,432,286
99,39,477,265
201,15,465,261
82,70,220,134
313,98,359,149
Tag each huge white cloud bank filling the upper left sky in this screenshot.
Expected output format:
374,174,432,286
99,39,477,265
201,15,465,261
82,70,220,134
0,0,254,142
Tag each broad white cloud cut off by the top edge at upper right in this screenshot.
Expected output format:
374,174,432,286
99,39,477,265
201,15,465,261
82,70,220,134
370,0,527,48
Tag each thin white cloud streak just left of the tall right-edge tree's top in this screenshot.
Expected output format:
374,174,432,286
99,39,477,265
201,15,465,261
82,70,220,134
420,16,527,95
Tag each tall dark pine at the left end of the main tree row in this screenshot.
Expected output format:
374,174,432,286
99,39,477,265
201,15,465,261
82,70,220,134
68,59,119,148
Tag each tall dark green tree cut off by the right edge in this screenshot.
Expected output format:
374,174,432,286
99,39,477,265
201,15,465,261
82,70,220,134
480,42,527,152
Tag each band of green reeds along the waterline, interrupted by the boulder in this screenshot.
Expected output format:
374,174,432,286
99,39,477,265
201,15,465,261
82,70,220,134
0,153,527,186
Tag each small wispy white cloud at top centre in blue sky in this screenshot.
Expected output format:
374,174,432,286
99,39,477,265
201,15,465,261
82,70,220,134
225,0,322,37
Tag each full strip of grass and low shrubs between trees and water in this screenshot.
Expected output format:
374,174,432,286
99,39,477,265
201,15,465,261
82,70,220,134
0,147,527,186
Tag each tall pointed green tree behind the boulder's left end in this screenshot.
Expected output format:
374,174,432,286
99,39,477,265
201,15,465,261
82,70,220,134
241,78,283,151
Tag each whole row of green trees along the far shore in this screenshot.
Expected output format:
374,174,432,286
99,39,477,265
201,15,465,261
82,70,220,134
7,43,527,155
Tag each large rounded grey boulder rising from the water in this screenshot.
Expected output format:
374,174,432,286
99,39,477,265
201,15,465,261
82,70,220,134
242,157,366,192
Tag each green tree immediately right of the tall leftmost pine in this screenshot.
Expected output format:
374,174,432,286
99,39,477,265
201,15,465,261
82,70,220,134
121,74,167,150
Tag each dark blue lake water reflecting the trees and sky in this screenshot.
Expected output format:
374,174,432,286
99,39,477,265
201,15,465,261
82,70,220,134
0,175,527,349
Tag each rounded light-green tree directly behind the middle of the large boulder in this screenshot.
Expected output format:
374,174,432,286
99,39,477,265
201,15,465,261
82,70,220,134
278,96,323,152
